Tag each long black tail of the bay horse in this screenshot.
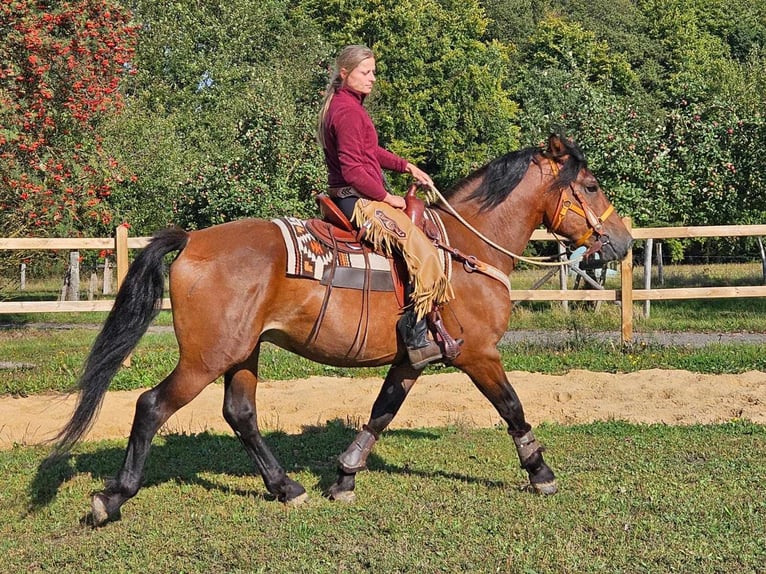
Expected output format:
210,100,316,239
54,228,188,454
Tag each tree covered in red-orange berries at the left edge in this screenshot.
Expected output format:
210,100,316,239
0,0,136,236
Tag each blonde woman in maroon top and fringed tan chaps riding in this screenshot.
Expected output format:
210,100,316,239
318,45,454,368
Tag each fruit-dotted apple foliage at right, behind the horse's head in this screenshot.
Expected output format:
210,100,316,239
513,3,764,238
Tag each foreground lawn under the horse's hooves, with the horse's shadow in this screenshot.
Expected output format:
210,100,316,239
0,422,766,574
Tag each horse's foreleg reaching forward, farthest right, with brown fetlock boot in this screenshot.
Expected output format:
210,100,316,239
460,356,558,494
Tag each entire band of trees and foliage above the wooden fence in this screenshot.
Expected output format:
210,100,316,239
0,0,766,249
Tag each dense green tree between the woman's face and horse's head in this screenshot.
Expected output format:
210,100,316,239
305,0,518,186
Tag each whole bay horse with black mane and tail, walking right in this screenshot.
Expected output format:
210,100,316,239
54,135,632,526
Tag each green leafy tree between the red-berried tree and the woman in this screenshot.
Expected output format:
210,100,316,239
102,0,327,233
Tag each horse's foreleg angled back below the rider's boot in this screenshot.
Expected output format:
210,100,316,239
328,363,421,502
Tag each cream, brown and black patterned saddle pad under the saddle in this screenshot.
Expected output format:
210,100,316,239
271,217,391,281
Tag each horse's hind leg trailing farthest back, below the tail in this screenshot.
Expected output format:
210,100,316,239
91,363,215,526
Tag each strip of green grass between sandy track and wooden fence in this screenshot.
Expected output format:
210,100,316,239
6,328,766,396
